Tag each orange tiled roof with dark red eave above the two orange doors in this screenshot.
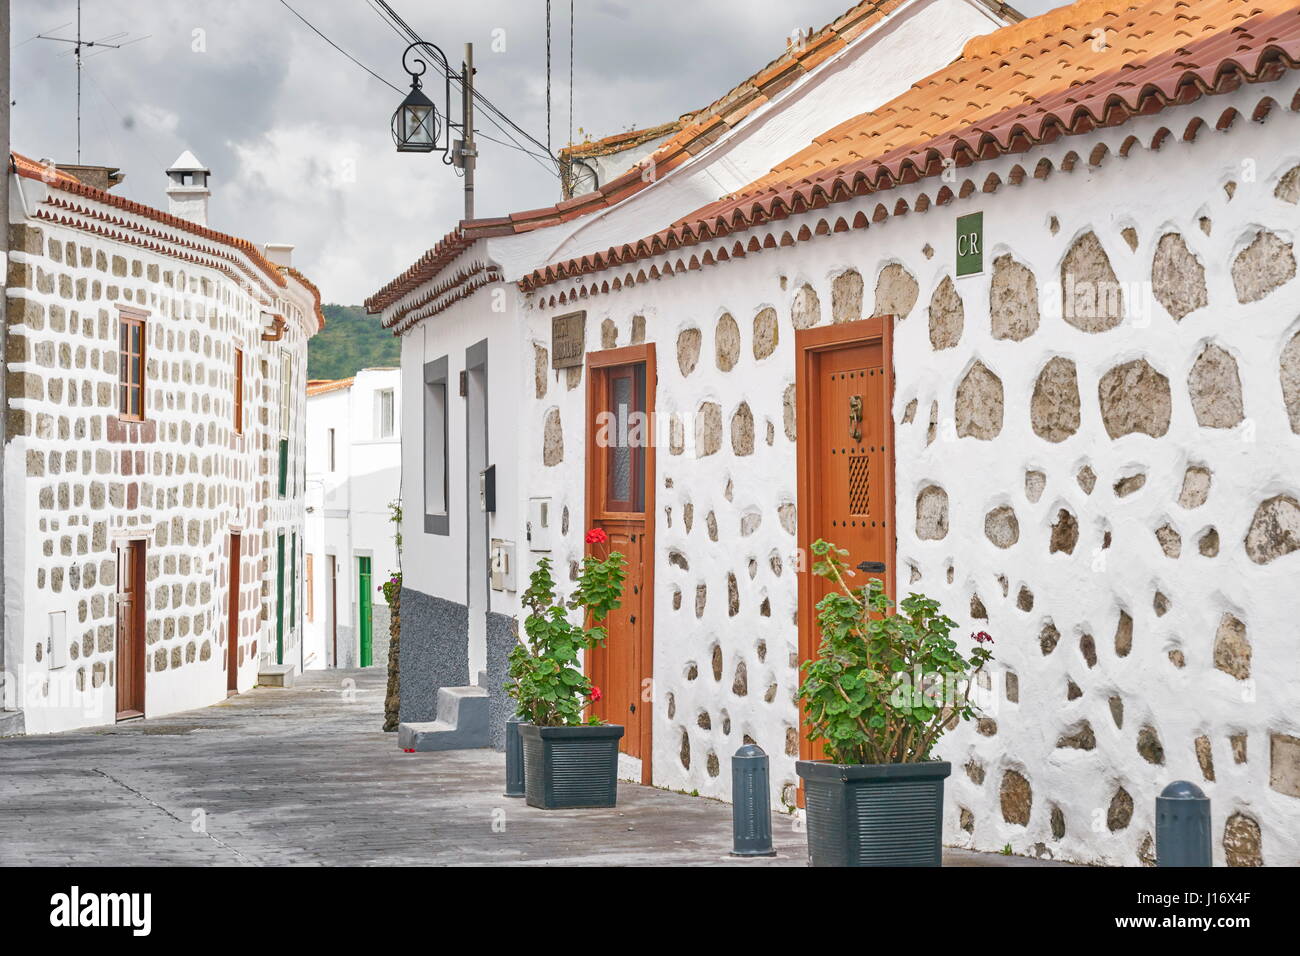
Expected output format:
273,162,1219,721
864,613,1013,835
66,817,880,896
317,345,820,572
520,0,1300,290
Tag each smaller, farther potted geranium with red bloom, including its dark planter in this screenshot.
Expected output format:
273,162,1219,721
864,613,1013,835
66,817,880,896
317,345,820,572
507,528,627,810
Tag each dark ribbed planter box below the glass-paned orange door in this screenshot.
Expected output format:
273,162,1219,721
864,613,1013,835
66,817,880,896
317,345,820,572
519,723,623,810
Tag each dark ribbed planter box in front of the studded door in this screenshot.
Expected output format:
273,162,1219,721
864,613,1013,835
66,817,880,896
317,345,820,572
794,760,953,866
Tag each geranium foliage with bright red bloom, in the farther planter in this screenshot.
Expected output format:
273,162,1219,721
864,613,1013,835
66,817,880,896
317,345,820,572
507,528,627,727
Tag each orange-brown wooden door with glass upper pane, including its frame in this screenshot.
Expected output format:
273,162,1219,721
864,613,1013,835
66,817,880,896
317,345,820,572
586,346,655,783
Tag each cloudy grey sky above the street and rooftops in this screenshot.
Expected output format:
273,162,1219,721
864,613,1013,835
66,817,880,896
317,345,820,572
12,0,1060,304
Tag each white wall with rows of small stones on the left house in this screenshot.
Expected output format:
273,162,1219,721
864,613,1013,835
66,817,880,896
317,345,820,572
4,182,316,732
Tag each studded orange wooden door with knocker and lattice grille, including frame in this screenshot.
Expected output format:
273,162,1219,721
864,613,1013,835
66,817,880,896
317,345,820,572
796,316,896,760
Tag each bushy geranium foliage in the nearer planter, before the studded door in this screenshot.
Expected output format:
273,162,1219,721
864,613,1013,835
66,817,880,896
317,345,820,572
800,540,993,763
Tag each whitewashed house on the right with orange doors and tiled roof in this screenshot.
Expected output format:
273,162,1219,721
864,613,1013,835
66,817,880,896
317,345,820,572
372,0,1300,865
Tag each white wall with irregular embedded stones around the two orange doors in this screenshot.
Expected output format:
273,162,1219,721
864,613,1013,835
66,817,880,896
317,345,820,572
521,86,1300,865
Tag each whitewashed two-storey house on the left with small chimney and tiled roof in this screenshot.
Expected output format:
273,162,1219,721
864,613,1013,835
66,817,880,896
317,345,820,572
4,152,324,734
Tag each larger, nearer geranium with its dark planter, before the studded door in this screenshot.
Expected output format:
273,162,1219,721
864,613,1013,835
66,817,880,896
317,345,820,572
796,540,993,866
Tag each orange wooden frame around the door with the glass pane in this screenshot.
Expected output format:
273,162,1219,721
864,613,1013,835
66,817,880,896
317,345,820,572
582,342,659,786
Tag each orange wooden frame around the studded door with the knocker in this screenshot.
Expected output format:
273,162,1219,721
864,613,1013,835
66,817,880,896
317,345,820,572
794,315,898,764
